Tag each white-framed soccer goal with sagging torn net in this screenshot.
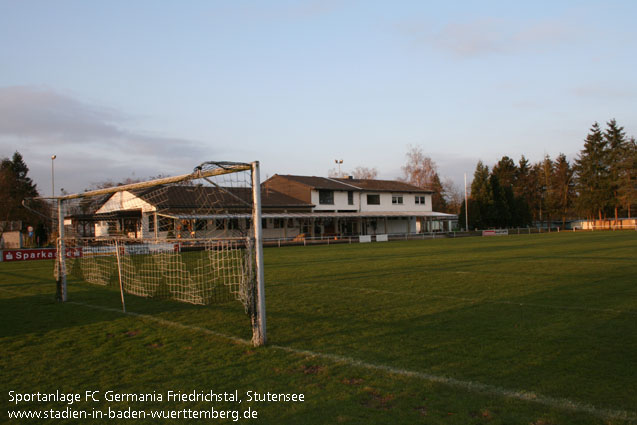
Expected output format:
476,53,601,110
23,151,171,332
55,162,266,346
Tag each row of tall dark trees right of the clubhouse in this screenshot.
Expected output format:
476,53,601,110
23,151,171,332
459,120,637,229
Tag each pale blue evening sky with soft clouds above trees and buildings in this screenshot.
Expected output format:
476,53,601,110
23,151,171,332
0,0,637,195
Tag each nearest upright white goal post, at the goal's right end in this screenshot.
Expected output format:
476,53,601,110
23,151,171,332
251,161,267,346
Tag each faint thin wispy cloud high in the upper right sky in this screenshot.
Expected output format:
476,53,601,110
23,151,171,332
400,18,575,58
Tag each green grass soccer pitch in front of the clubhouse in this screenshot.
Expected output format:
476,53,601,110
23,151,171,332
0,231,637,425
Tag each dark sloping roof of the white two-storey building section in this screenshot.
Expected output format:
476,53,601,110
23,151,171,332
268,174,433,193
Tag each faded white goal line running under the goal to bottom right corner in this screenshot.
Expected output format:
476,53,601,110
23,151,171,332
67,301,637,421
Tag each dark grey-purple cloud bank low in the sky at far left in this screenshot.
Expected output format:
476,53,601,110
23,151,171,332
0,86,209,161
